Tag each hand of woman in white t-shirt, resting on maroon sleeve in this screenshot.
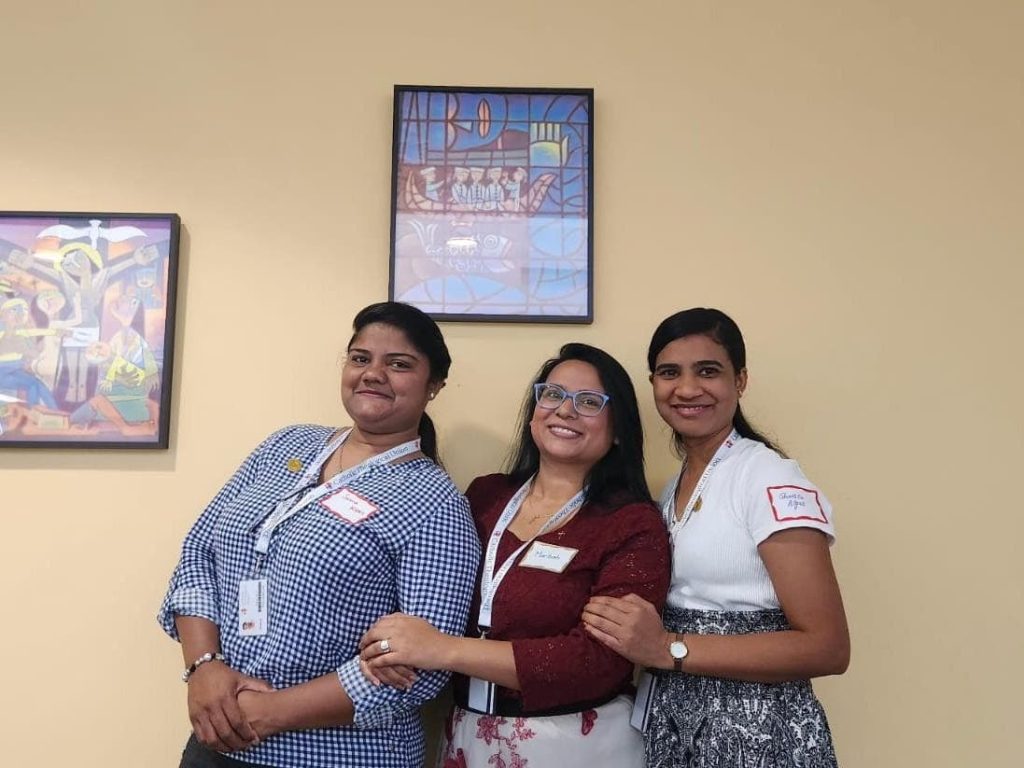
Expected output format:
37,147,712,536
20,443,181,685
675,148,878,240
583,595,673,669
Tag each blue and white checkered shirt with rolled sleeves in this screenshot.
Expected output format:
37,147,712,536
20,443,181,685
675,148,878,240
159,425,480,768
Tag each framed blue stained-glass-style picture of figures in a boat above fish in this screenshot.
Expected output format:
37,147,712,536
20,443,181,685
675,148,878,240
389,85,594,323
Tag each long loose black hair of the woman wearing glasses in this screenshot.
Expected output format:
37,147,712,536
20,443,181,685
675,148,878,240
506,343,651,507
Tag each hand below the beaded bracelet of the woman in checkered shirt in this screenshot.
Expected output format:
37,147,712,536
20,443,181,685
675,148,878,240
188,662,273,752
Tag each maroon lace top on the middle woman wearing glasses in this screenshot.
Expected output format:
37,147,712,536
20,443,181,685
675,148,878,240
455,474,670,714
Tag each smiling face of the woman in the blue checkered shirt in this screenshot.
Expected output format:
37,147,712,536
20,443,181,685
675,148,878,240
341,323,440,434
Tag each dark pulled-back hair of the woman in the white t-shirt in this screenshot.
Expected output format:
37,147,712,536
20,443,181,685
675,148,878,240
647,307,784,456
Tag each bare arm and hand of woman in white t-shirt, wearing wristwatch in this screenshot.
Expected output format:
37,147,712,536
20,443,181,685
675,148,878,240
584,528,850,683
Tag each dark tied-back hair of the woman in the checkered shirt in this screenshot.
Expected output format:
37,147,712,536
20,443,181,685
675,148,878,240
348,301,452,464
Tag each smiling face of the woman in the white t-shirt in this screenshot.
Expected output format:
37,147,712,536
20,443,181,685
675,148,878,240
650,335,746,444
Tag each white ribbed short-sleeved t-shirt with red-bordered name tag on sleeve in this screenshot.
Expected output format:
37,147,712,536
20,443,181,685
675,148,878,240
662,437,836,610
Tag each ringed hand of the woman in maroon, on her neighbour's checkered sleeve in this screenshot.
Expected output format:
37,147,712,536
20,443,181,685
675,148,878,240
359,613,455,688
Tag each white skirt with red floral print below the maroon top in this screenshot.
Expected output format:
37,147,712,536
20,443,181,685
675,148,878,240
437,695,644,768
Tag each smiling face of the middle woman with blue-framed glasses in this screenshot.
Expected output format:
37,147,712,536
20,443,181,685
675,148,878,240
529,360,615,471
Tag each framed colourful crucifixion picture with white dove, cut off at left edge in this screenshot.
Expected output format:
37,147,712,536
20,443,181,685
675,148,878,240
0,212,179,449
